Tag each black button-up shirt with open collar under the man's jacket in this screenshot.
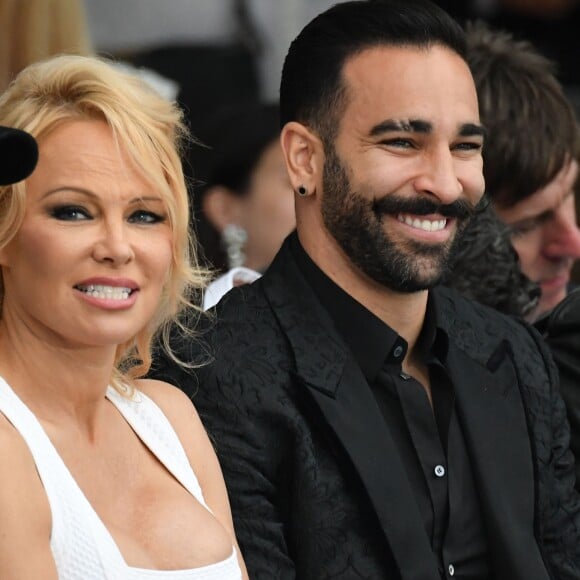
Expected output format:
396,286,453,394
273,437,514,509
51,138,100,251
291,236,492,580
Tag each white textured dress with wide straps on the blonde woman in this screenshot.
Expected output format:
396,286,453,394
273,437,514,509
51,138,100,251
0,377,242,580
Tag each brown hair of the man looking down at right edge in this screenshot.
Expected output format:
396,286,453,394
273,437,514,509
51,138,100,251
467,22,579,207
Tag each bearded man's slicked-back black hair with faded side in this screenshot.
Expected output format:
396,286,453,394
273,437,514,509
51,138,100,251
280,0,465,143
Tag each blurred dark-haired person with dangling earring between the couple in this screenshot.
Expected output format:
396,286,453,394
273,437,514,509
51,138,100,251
191,103,296,309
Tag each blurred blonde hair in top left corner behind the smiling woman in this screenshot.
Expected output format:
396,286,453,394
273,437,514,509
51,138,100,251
0,0,92,90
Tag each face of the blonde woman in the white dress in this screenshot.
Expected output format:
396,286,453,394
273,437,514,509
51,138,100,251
0,120,172,348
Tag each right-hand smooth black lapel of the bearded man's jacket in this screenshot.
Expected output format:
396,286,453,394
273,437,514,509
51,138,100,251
446,341,548,580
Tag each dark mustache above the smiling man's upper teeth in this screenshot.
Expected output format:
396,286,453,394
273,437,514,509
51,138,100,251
373,195,489,220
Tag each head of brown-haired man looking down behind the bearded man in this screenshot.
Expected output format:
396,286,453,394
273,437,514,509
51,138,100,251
467,22,580,317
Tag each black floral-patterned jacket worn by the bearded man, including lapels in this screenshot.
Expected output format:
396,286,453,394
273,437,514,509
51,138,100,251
157,237,580,580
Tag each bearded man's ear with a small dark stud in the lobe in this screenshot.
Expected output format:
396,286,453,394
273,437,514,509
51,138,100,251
280,121,324,195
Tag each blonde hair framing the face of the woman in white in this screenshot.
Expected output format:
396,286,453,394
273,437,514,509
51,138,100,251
0,56,208,391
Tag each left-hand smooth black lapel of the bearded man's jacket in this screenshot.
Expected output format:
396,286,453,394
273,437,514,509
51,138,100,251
263,243,439,580
